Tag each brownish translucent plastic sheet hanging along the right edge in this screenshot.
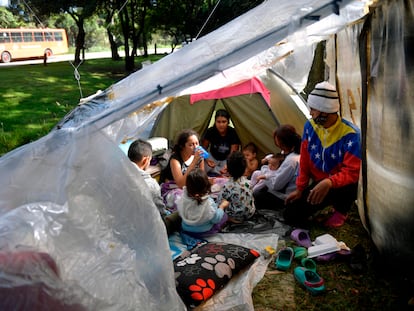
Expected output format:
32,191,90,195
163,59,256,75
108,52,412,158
364,1,414,264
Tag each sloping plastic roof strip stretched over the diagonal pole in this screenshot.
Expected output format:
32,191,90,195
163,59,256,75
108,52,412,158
54,0,364,136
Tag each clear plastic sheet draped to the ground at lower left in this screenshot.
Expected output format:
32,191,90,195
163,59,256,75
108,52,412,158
0,131,184,310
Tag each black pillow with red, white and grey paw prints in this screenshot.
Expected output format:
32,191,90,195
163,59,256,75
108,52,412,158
174,242,260,308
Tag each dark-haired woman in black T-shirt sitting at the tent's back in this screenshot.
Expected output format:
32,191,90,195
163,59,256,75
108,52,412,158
201,109,240,176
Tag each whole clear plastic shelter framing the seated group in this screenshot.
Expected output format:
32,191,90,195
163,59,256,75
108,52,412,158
0,0,414,310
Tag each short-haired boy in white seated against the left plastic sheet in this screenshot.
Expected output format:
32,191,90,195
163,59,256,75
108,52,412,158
128,139,180,234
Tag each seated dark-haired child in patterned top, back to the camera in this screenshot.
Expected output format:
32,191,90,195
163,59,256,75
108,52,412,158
217,151,256,223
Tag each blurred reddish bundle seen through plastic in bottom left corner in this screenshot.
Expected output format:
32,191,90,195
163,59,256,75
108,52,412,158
0,249,88,311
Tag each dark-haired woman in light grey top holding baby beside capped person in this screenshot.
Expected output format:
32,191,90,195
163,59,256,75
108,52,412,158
253,124,301,209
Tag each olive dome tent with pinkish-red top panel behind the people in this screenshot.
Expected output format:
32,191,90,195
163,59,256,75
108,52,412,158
149,72,306,158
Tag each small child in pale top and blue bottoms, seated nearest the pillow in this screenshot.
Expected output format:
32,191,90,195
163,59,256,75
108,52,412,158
177,168,229,238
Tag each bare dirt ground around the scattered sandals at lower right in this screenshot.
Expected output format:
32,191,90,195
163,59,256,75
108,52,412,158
252,208,414,311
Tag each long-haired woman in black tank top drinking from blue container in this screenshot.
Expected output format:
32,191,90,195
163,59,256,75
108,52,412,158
159,129,204,211
